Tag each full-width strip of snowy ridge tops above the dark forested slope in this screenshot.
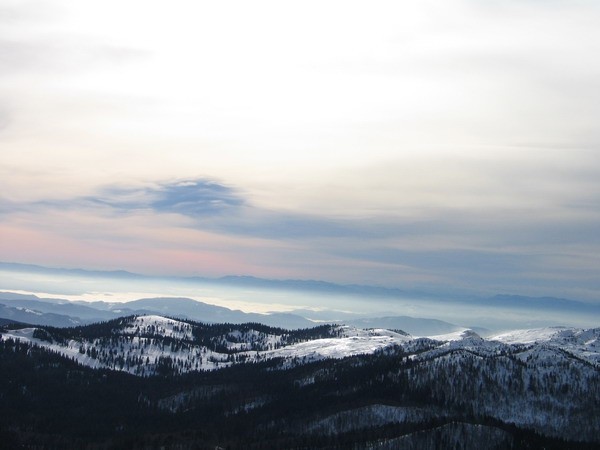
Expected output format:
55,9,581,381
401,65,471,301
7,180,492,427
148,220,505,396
2,315,600,376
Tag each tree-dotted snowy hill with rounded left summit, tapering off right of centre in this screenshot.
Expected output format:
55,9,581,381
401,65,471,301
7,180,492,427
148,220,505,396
2,315,418,376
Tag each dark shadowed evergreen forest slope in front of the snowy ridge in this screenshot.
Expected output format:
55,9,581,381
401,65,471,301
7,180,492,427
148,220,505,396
0,339,599,450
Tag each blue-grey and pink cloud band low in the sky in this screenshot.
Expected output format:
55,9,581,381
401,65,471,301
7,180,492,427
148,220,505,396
2,173,600,300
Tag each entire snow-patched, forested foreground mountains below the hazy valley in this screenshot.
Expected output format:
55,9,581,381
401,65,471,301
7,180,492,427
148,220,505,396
0,315,600,450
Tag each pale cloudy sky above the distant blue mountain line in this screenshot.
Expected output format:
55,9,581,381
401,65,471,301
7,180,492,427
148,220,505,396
0,0,600,302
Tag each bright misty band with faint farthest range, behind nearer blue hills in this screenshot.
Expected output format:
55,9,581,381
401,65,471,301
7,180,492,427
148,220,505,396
0,260,598,330
